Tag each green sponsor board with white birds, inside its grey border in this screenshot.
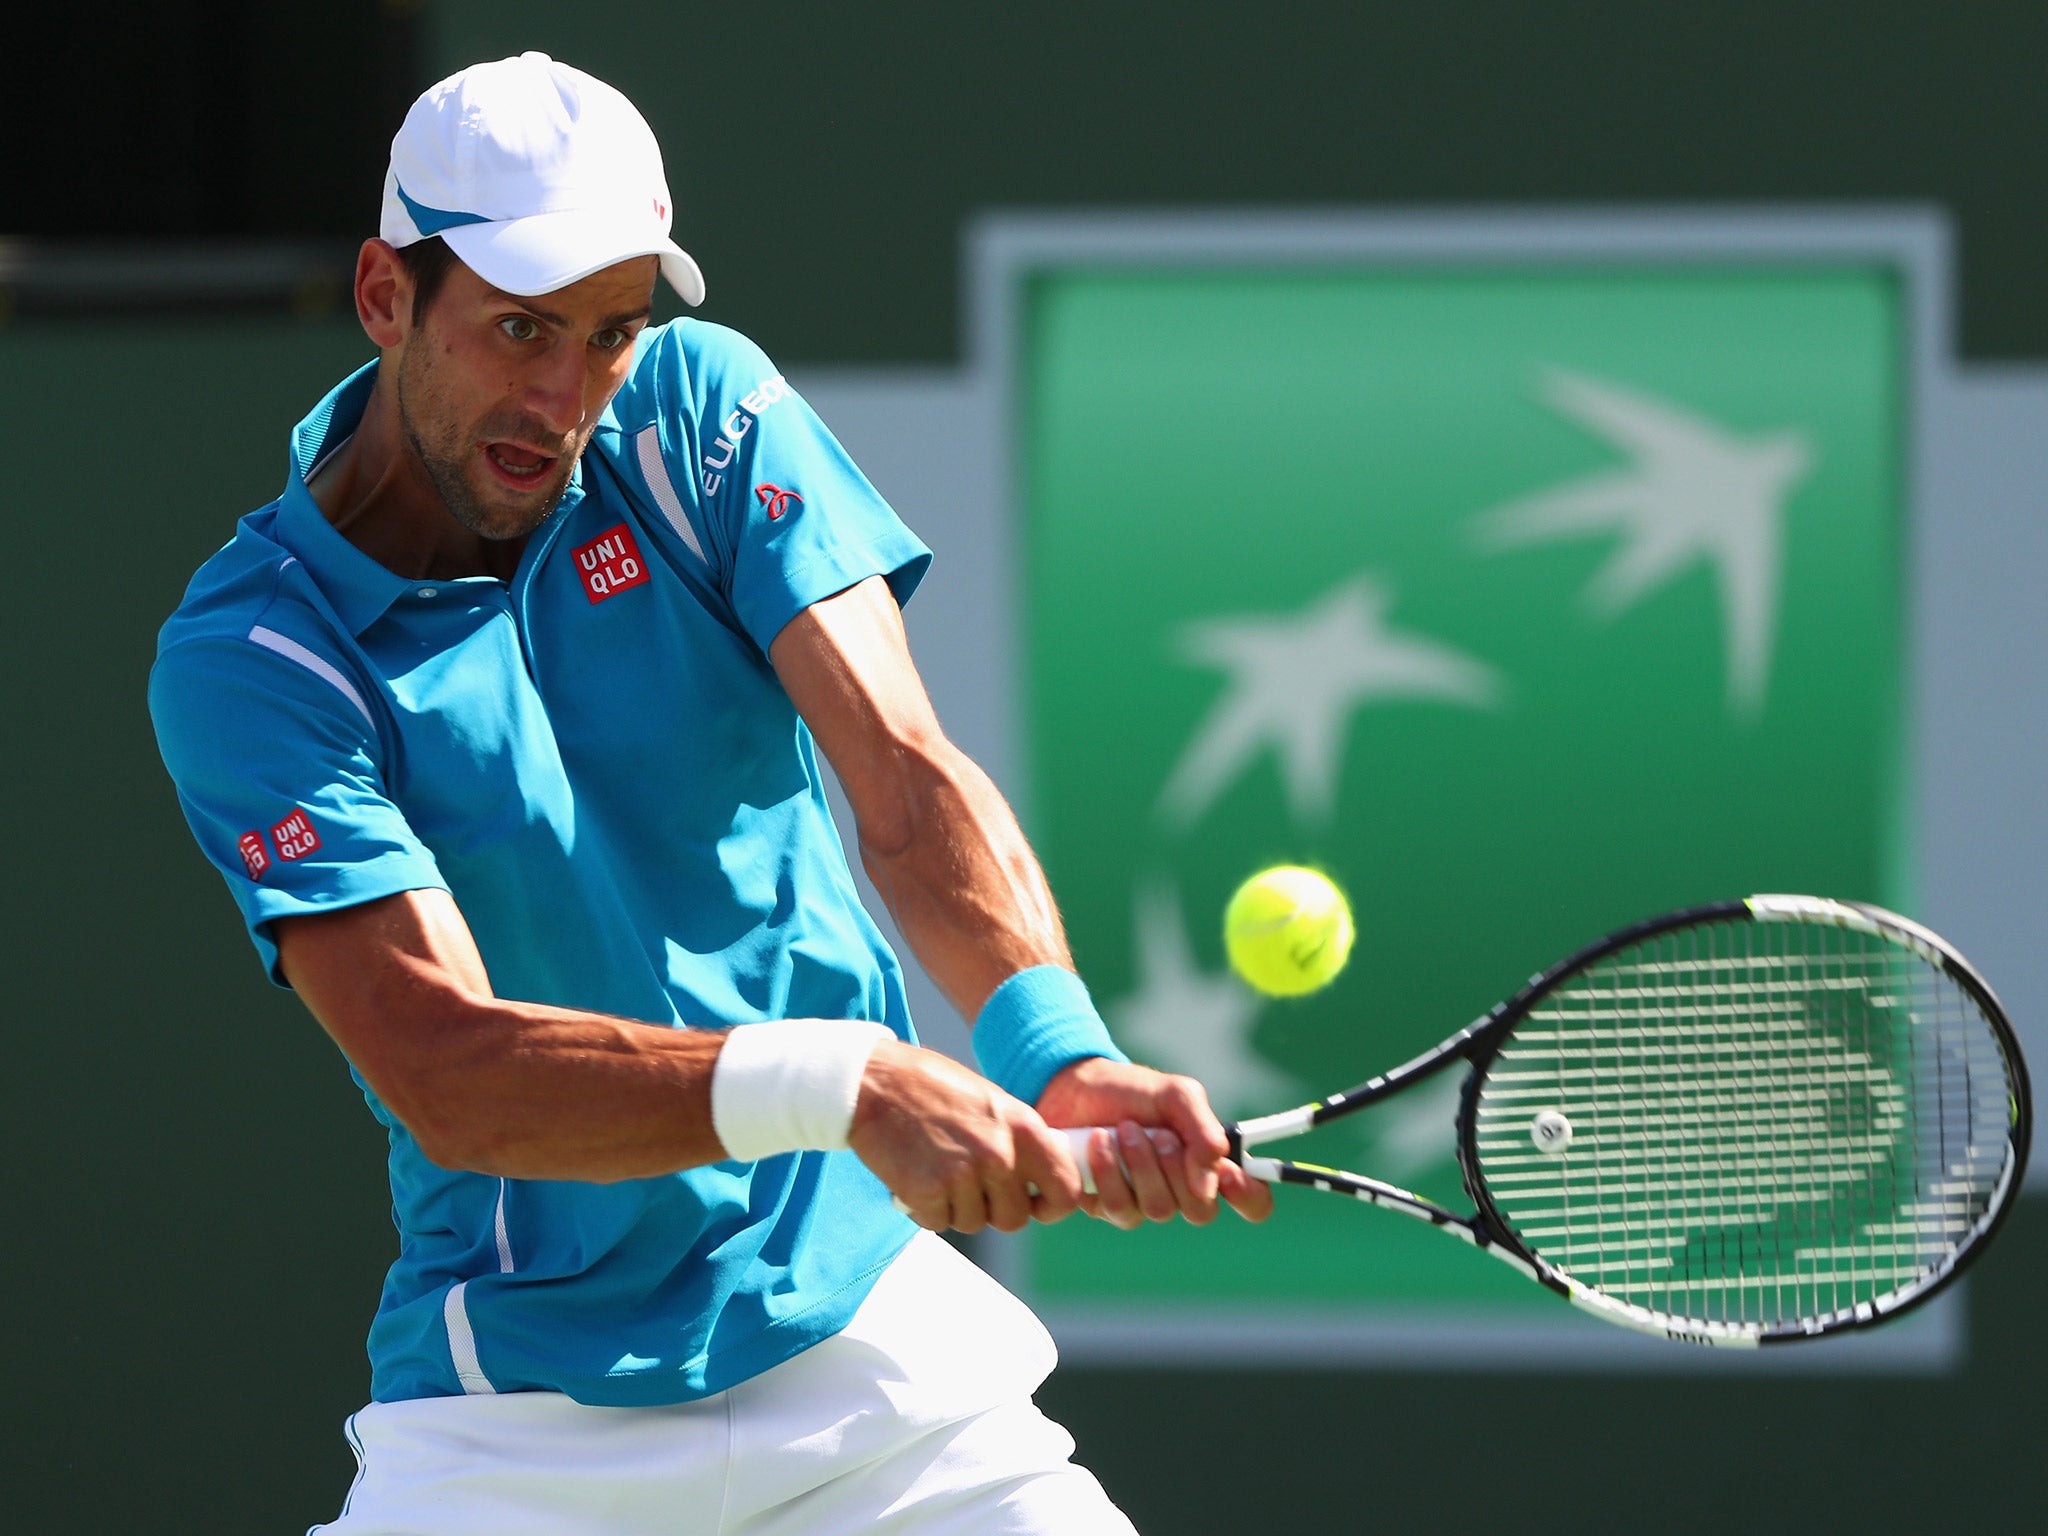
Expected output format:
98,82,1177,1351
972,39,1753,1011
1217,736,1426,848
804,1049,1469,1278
1016,262,1909,1319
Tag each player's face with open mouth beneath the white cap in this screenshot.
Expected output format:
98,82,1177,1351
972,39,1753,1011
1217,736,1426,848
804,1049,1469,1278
397,256,657,539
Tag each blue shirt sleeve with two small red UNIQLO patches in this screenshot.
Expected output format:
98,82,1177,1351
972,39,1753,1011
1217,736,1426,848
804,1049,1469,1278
150,639,446,987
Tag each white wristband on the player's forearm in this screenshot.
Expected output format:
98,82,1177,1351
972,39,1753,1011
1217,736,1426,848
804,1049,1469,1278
711,1018,895,1163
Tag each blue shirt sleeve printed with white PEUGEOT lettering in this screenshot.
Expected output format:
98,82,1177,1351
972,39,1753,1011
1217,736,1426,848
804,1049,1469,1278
649,322,932,651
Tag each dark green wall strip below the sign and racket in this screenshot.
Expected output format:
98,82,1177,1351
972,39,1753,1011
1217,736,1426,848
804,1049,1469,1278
1038,1200,2048,1536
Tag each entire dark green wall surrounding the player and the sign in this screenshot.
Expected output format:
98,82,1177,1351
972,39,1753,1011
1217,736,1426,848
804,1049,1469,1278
0,0,2048,1534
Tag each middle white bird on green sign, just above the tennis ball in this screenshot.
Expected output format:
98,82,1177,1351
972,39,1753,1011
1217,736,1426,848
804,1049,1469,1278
1159,575,1499,827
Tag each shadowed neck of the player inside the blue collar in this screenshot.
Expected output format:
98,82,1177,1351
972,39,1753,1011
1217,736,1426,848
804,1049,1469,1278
305,373,526,582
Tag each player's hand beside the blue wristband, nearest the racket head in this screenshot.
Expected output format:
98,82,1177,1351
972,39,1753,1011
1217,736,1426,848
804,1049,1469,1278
1038,1057,1274,1227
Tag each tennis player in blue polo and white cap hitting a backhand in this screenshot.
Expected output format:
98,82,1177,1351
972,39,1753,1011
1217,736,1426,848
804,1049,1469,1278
150,53,1270,1536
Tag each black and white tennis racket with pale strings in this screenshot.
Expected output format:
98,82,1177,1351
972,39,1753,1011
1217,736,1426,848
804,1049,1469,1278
1081,895,2032,1346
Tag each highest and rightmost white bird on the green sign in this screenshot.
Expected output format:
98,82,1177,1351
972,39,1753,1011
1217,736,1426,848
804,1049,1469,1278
1475,371,1815,719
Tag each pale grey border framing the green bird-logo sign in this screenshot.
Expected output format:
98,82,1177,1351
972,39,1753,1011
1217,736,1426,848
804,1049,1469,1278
965,207,1968,1376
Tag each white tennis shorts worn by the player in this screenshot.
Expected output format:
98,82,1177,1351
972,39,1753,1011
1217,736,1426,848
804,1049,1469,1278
307,1233,1135,1536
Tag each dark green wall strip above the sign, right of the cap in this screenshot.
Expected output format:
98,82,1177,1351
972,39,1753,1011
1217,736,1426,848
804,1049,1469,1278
422,0,2048,360
